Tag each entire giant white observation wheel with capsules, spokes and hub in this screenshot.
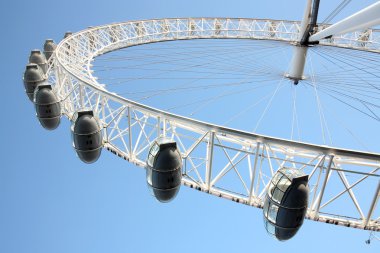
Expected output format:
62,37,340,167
24,0,380,240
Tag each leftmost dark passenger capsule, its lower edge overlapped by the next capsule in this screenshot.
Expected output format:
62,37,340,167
23,63,46,102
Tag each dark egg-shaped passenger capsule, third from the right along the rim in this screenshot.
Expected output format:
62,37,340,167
71,111,103,163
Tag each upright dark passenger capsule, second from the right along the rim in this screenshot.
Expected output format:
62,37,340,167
146,138,182,202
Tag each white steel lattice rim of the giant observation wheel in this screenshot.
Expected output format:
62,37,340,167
23,2,380,240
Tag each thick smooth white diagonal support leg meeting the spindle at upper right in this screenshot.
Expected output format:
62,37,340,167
309,2,380,41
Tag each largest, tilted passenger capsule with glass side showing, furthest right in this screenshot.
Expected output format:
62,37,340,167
263,168,309,241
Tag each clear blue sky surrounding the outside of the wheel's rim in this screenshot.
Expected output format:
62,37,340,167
0,0,380,253
